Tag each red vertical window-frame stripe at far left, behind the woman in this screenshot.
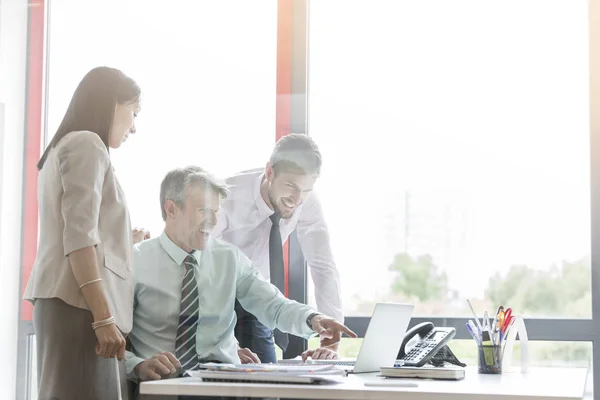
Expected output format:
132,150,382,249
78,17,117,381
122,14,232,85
21,0,46,321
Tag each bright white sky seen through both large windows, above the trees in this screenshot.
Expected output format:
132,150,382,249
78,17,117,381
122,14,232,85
48,0,590,309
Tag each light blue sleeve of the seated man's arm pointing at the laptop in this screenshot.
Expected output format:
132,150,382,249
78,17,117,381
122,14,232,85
234,248,315,338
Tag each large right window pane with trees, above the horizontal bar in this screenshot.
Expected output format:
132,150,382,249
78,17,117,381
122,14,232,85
309,0,591,318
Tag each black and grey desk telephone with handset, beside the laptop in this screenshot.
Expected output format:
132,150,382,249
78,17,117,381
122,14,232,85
397,322,465,367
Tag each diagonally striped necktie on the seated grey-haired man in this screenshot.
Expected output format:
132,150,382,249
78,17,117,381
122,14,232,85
175,255,200,372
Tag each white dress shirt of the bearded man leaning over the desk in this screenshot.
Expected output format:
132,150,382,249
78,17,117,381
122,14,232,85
212,169,344,323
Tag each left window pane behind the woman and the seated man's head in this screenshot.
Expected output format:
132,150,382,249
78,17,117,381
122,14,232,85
48,0,277,236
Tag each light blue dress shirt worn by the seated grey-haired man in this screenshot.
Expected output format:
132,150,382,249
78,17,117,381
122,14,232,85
126,232,315,379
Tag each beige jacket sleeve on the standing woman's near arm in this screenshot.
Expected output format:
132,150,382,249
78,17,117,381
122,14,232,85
58,132,110,256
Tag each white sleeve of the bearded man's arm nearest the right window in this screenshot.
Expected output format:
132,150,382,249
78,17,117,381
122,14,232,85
297,193,344,323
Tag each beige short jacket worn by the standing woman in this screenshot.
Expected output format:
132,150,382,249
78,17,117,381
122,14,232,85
24,131,134,334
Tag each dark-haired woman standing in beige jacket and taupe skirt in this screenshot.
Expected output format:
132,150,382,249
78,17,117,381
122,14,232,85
25,67,140,400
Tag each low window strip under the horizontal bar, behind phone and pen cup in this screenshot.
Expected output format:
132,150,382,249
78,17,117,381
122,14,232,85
308,338,592,368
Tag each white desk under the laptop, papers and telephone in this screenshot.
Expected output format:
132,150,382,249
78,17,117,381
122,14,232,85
140,367,587,400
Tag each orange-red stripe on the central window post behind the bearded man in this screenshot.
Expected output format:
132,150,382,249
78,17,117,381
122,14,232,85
275,0,293,297
